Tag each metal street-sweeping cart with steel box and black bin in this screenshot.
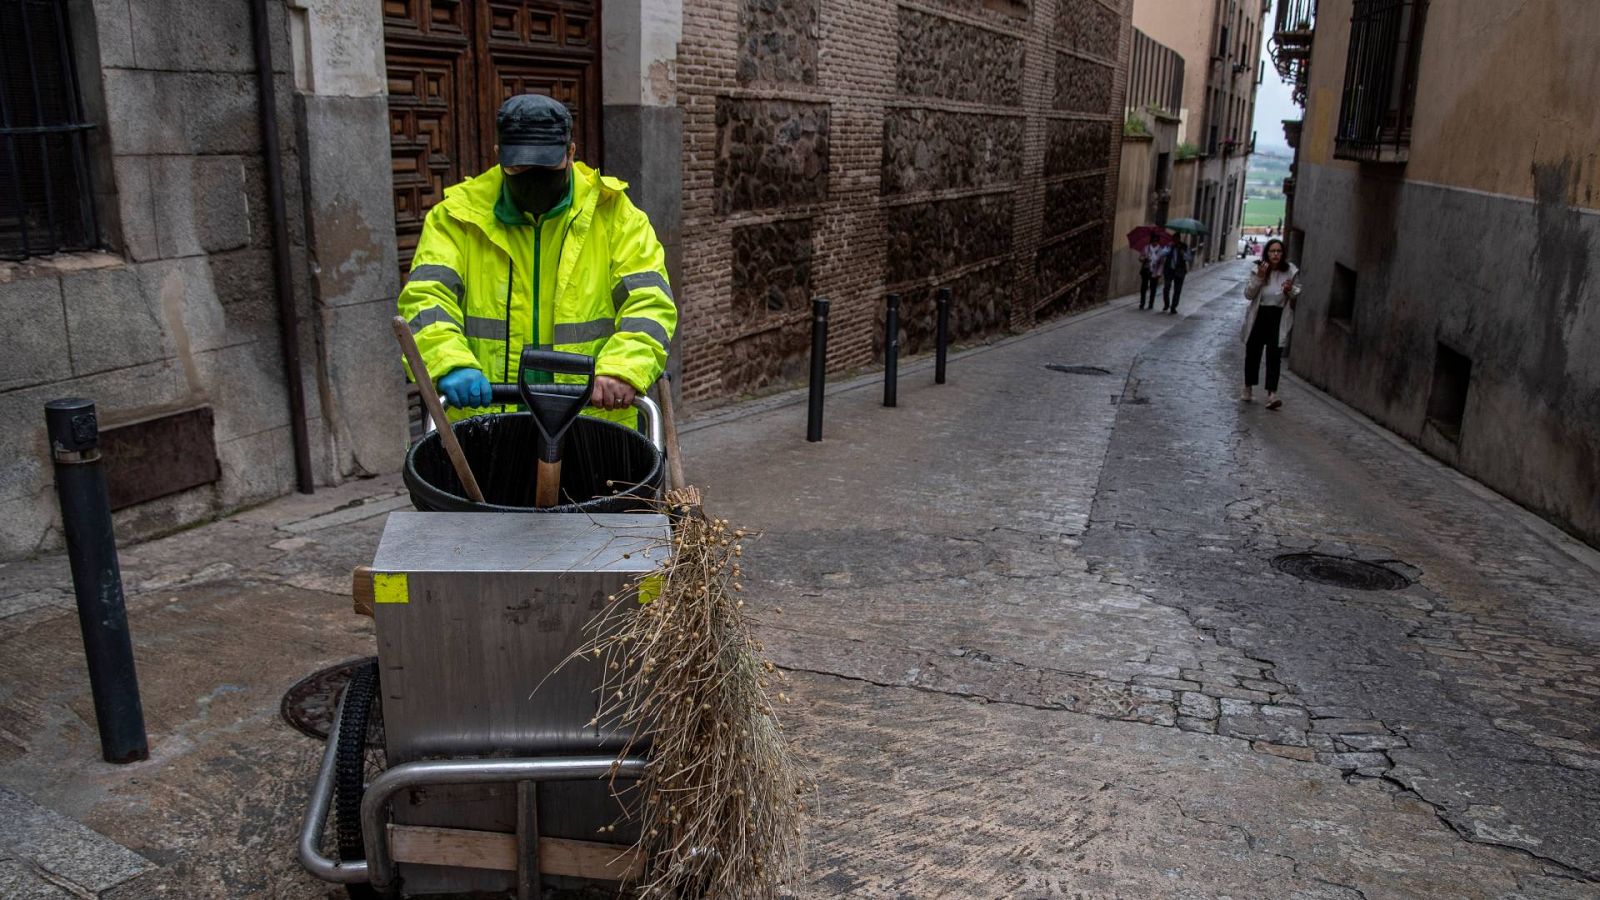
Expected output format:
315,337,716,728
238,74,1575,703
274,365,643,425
299,349,670,900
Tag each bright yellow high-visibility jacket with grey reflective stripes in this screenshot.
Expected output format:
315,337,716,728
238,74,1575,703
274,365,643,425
398,162,678,424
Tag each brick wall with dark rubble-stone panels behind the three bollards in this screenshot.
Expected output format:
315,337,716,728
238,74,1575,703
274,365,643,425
675,0,1131,402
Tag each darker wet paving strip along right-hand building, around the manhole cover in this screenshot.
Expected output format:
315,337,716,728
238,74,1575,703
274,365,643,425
1083,286,1600,876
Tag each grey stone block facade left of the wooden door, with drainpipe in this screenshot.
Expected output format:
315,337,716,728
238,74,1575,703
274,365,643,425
0,0,405,557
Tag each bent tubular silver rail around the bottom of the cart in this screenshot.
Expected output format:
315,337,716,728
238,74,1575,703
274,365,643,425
299,692,648,890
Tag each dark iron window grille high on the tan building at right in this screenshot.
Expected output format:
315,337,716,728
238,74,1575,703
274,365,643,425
1333,0,1427,162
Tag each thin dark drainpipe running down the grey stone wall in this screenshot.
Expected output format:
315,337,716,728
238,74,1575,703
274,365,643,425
250,0,315,493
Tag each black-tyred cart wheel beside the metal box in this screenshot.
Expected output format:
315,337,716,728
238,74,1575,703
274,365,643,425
333,658,386,900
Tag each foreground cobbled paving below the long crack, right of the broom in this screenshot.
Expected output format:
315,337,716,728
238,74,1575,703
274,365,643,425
790,674,1594,900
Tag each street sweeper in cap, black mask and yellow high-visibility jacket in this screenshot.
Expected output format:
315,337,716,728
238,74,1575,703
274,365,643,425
398,94,678,426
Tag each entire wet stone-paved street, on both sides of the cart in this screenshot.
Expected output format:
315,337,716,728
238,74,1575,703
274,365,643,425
0,264,1600,900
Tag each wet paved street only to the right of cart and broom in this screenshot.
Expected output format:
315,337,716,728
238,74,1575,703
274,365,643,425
690,257,1600,897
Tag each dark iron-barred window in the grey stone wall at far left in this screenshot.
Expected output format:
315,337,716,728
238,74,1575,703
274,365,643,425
0,0,99,259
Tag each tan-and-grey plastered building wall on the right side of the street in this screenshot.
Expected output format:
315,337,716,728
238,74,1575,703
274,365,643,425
1278,0,1600,544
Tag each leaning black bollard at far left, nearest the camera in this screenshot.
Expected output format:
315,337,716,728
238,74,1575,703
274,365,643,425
45,399,150,762
